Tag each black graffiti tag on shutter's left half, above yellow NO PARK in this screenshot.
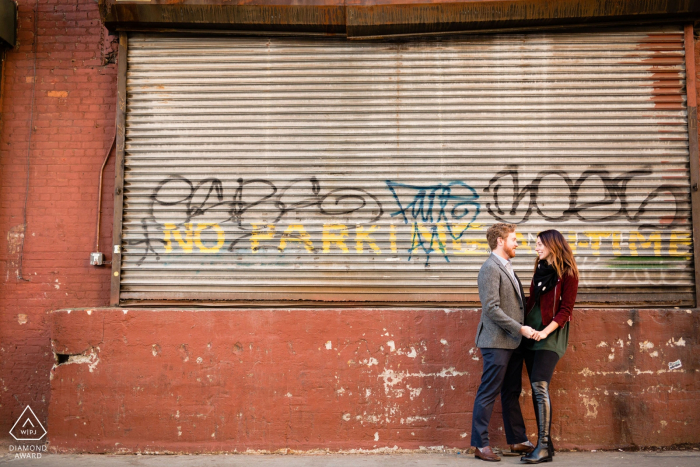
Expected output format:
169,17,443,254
127,175,384,266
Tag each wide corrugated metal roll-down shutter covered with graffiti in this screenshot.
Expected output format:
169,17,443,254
121,27,694,305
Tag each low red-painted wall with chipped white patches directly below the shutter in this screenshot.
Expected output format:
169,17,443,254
49,309,700,452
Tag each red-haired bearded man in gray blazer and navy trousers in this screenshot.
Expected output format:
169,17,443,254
471,223,534,462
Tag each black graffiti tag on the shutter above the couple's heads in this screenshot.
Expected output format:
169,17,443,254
484,165,688,229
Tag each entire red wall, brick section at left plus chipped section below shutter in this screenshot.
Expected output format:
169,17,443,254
0,0,700,451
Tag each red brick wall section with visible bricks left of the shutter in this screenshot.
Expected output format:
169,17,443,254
0,0,116,437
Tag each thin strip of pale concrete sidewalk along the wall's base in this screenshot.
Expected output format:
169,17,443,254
0,450,700,467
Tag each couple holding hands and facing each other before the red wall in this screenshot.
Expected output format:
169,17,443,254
471,224,578,464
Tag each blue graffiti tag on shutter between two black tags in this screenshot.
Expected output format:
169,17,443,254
386,180,481,266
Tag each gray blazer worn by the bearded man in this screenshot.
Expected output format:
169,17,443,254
476,254,525,349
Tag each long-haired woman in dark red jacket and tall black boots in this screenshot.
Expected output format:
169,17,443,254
520,230,578,464
